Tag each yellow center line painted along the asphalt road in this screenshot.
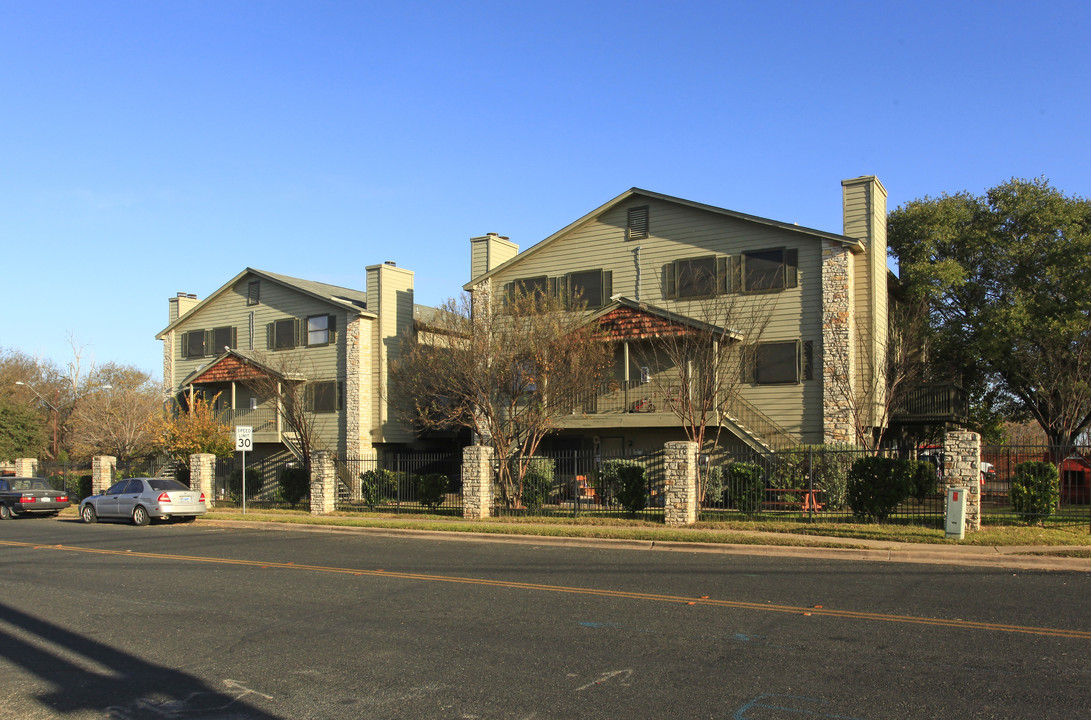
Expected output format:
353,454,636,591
8,540,1091,640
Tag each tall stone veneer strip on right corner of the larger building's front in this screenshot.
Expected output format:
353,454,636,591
820,240,856,444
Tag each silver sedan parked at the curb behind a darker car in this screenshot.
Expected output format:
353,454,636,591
80,478,207,525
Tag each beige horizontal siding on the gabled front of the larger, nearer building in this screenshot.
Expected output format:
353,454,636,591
486,195,822,442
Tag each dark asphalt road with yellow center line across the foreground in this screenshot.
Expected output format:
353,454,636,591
0,519,1091,720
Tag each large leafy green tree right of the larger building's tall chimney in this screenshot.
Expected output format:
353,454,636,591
888,179,1091,446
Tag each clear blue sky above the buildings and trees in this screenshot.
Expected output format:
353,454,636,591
0,0,1091,376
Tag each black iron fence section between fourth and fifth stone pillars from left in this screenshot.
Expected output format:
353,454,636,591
335,452,463,515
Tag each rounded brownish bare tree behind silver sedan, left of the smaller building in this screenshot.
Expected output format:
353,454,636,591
68,363,163,460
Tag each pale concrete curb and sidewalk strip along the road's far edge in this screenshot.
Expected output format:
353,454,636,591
201,517,1091,573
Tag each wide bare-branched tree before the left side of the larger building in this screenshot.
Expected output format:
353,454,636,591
391,287,613,507
